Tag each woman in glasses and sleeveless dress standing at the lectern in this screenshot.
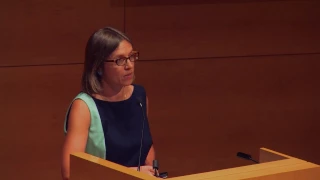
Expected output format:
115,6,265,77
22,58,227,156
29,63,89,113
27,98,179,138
62,27,155,179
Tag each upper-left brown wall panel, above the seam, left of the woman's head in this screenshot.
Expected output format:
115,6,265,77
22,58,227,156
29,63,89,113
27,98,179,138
0,0,124,66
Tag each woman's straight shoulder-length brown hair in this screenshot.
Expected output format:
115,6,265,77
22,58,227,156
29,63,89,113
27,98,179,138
81,27,131,95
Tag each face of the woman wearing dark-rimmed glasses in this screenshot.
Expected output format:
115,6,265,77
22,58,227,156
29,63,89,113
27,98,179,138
103,40,134,86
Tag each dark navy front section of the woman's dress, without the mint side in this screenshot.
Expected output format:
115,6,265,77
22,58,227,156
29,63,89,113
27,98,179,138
93,84,153,167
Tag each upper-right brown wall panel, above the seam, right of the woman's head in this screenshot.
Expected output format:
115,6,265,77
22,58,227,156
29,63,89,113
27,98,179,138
125,0,320,60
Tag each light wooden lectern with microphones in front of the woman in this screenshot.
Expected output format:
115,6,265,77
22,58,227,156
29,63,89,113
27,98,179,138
70,148,320,180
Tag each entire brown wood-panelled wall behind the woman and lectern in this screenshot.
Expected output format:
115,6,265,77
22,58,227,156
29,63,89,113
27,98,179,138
0,0,320,180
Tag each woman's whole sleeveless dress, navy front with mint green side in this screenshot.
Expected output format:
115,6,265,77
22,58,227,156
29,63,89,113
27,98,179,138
64,84,153,167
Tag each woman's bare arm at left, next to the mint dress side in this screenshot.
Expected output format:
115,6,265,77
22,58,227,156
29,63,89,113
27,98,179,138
61,99,90,180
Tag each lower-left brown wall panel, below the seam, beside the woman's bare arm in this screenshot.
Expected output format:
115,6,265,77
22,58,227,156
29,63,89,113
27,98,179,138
0,65,82,180
